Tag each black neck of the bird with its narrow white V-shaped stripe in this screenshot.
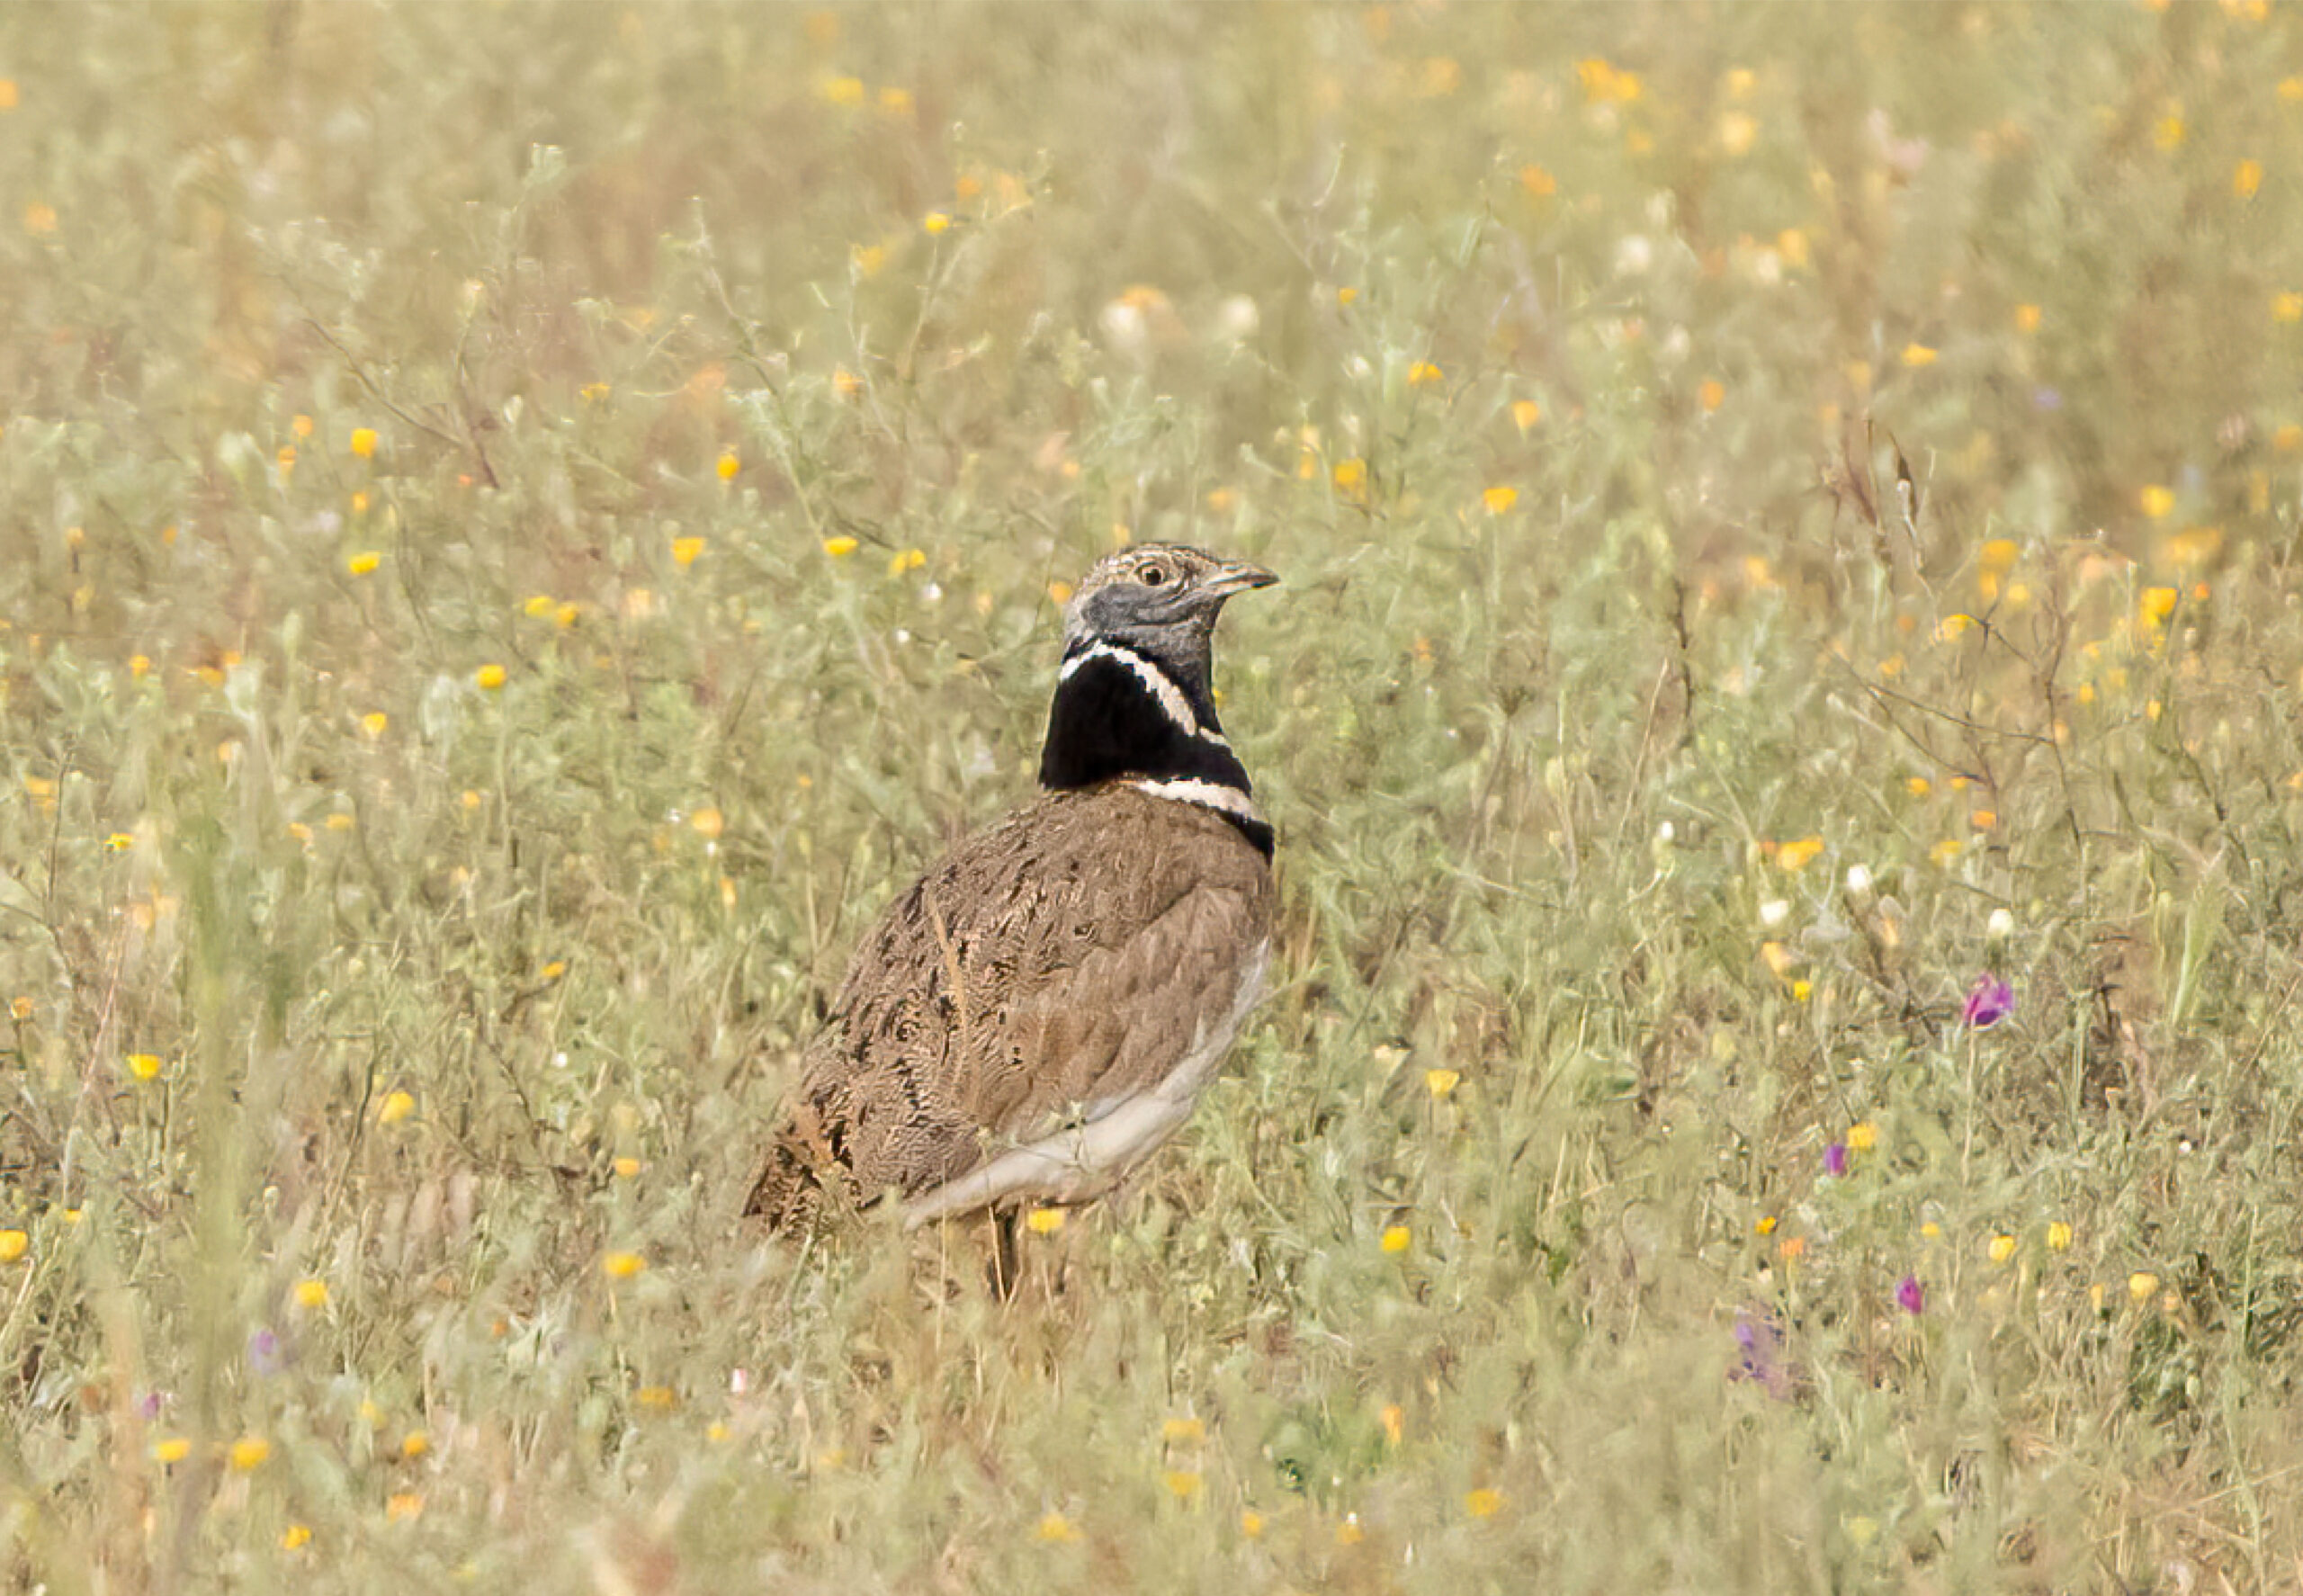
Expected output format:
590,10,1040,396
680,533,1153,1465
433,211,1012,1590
1039,638,1271,850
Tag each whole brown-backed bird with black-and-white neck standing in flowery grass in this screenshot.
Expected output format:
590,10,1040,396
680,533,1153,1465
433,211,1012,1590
744,543,1278,1253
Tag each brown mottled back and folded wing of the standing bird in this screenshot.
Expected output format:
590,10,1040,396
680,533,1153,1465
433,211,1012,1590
746,783,1274,1225
